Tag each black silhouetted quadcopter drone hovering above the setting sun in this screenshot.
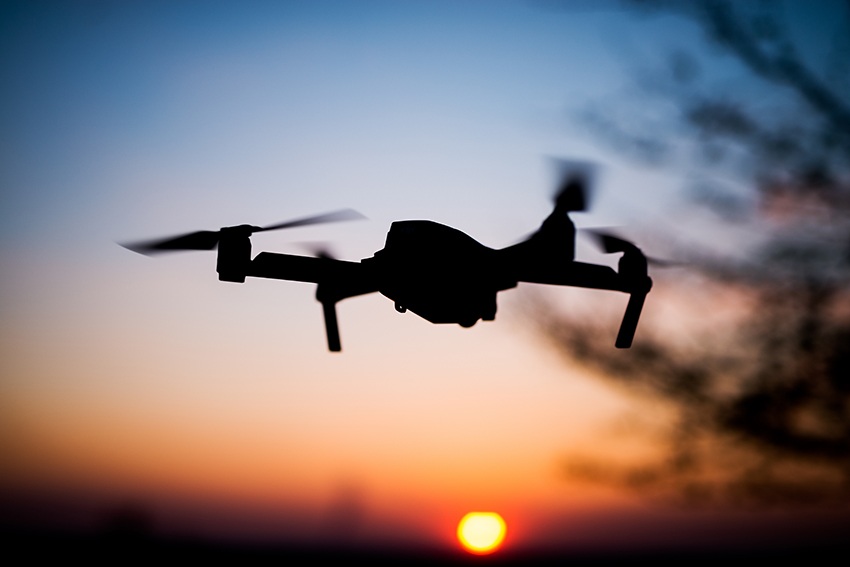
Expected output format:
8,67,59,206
122,168,652,352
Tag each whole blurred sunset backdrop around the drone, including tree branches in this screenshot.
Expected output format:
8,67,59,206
0,0,850,554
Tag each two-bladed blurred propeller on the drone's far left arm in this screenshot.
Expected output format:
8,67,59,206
121,209,366,256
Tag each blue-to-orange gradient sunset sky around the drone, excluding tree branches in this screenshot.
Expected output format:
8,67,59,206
0,0,848,560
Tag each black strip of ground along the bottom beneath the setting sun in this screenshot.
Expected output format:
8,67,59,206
0,528,850,567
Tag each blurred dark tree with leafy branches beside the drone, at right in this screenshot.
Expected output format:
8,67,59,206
534,0,850,505
